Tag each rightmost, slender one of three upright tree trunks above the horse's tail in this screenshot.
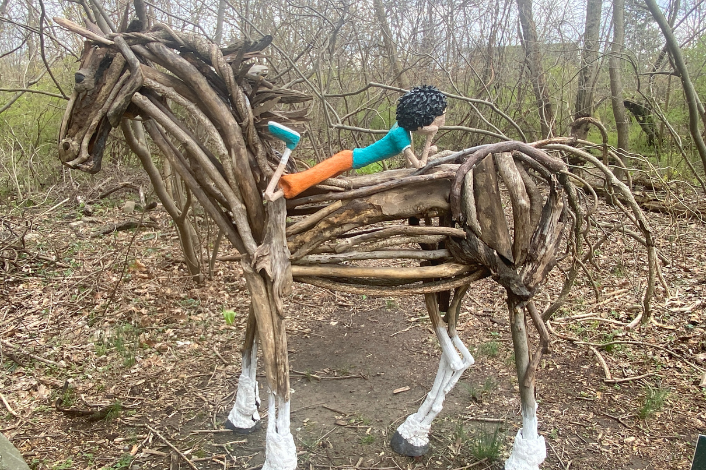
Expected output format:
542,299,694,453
608,0,628,179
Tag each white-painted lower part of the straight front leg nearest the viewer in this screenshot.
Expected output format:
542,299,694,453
262,391,297,470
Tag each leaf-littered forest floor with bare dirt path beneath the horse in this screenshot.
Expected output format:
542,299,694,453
0,173,706,470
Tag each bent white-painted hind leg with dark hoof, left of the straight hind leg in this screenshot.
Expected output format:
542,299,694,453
390,289,475,457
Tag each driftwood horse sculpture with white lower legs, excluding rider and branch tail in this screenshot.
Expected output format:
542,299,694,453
56,8,581,470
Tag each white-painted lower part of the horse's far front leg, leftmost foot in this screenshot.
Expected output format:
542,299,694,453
226,341,260,434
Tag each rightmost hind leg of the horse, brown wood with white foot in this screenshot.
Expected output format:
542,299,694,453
505,296,547,470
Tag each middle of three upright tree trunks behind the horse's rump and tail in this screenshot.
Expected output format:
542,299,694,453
573,0,603,140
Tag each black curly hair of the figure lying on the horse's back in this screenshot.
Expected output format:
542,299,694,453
397,85,446,131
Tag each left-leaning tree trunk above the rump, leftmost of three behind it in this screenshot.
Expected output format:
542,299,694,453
517,0,554,138
